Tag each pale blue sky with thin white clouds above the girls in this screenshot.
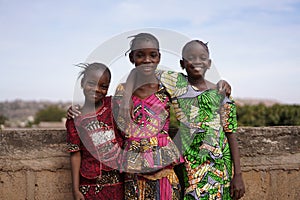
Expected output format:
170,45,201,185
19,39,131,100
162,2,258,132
0,0,300,104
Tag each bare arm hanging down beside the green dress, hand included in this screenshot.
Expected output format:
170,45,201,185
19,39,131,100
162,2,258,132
226,133,245,199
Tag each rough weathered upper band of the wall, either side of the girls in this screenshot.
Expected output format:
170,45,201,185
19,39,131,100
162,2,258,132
0,126,300,171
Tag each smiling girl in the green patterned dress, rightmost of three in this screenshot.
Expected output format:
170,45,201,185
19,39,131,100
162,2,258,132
159,40,245,200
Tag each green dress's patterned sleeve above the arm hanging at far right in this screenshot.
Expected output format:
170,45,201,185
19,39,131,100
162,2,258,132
221,97,237,133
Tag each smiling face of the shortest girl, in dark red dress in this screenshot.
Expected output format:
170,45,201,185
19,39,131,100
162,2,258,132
81,70,110,105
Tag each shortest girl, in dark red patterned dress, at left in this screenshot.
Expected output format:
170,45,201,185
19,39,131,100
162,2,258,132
66,63,124,200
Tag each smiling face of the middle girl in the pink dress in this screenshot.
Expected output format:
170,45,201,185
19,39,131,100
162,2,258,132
129,40,160,76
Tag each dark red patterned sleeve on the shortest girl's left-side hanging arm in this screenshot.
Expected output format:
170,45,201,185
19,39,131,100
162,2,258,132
66,119,81,152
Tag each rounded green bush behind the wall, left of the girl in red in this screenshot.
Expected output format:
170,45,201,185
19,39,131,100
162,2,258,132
34,105,66,124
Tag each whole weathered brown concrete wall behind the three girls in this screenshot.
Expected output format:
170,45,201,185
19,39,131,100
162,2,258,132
0,127,300,200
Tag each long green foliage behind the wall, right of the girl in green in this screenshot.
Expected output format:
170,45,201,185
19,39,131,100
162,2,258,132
237,104,300,126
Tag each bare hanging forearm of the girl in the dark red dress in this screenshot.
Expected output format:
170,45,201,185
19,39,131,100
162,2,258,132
70,151,84,200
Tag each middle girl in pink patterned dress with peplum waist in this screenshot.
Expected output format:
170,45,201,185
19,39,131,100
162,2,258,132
115,33,183,200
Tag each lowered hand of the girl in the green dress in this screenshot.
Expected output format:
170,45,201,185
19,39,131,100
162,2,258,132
230,173,245,199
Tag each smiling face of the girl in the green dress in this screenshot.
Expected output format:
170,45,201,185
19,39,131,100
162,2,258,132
180,41,211,79
